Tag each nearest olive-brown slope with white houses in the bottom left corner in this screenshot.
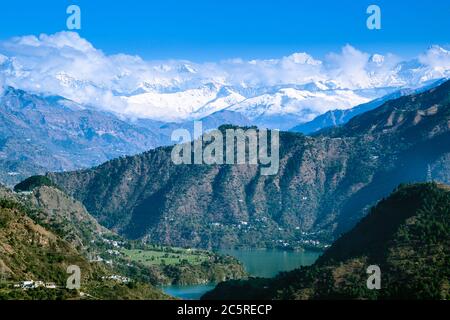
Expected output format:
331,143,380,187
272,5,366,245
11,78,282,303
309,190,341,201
0,186,168,300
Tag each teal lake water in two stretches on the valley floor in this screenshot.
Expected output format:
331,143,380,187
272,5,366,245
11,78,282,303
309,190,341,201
162,249,321,300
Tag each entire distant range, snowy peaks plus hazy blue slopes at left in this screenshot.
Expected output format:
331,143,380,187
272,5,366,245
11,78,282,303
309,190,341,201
0,42,450,186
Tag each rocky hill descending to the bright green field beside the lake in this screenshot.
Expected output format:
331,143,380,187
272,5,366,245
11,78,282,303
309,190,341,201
0,177,246,297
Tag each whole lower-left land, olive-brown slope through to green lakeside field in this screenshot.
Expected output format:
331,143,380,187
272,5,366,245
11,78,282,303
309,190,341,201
0,186,246,300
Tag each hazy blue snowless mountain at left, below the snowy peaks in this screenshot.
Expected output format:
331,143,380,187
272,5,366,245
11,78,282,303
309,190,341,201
0,87,253,185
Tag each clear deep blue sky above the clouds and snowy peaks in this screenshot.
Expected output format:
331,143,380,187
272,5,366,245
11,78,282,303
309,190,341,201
0,0,450,61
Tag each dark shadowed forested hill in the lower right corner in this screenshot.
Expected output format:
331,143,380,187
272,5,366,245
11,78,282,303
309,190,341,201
203,183,450,299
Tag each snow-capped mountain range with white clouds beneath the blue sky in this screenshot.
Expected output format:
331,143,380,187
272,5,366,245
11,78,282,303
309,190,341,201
0,32,450,130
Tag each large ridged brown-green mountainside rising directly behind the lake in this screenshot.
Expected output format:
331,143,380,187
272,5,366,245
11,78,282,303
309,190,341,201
44,82,450,248
